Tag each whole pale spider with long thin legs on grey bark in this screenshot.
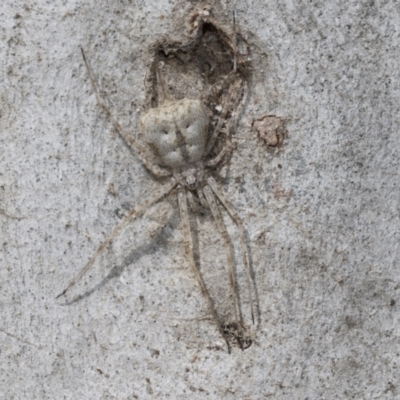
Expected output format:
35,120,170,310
57,10,254,352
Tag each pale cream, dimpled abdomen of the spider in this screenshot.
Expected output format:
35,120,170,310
140,99,209,168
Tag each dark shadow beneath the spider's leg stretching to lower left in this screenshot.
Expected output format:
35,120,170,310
60,208,180,306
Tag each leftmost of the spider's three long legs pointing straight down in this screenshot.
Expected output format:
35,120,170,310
178,189,231,353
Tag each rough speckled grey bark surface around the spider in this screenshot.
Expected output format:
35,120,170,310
0,0,400,399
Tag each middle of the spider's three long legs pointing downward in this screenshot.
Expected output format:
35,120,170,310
203,186,242,329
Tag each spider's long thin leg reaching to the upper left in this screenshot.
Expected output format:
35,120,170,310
81,47,171,176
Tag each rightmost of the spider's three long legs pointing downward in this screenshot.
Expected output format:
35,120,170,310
207,177,254,324
